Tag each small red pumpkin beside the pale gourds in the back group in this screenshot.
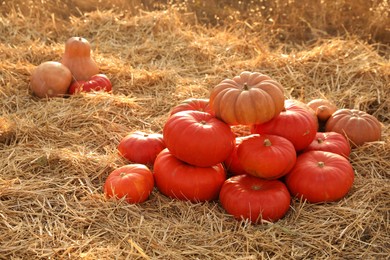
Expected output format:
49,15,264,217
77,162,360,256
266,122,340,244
68,74,112,95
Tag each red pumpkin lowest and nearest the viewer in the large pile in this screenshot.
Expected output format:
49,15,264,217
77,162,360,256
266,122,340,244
219,174,291,224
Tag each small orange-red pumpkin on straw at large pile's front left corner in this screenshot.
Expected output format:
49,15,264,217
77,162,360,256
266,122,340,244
103,164,154,204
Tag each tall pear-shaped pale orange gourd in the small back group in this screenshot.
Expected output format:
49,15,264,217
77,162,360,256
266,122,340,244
61,37,99,81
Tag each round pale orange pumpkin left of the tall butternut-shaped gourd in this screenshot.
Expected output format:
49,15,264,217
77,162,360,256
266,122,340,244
30,61,72,98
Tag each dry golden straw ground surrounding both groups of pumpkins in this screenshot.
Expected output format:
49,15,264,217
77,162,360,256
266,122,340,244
0,0,390,259
